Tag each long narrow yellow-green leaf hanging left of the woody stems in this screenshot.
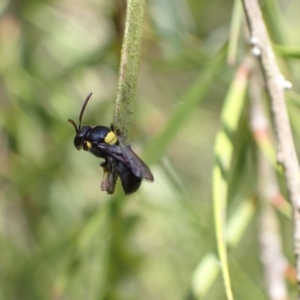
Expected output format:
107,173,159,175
212,61,249,300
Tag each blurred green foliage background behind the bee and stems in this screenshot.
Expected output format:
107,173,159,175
0,0,300,300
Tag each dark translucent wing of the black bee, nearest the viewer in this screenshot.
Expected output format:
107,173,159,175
117,135,154,182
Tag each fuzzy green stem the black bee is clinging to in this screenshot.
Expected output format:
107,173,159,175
113,0,145,138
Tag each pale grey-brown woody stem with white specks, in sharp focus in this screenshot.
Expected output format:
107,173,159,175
242,0,300,299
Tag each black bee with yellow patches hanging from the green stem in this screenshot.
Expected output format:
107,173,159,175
68,93,154,194
